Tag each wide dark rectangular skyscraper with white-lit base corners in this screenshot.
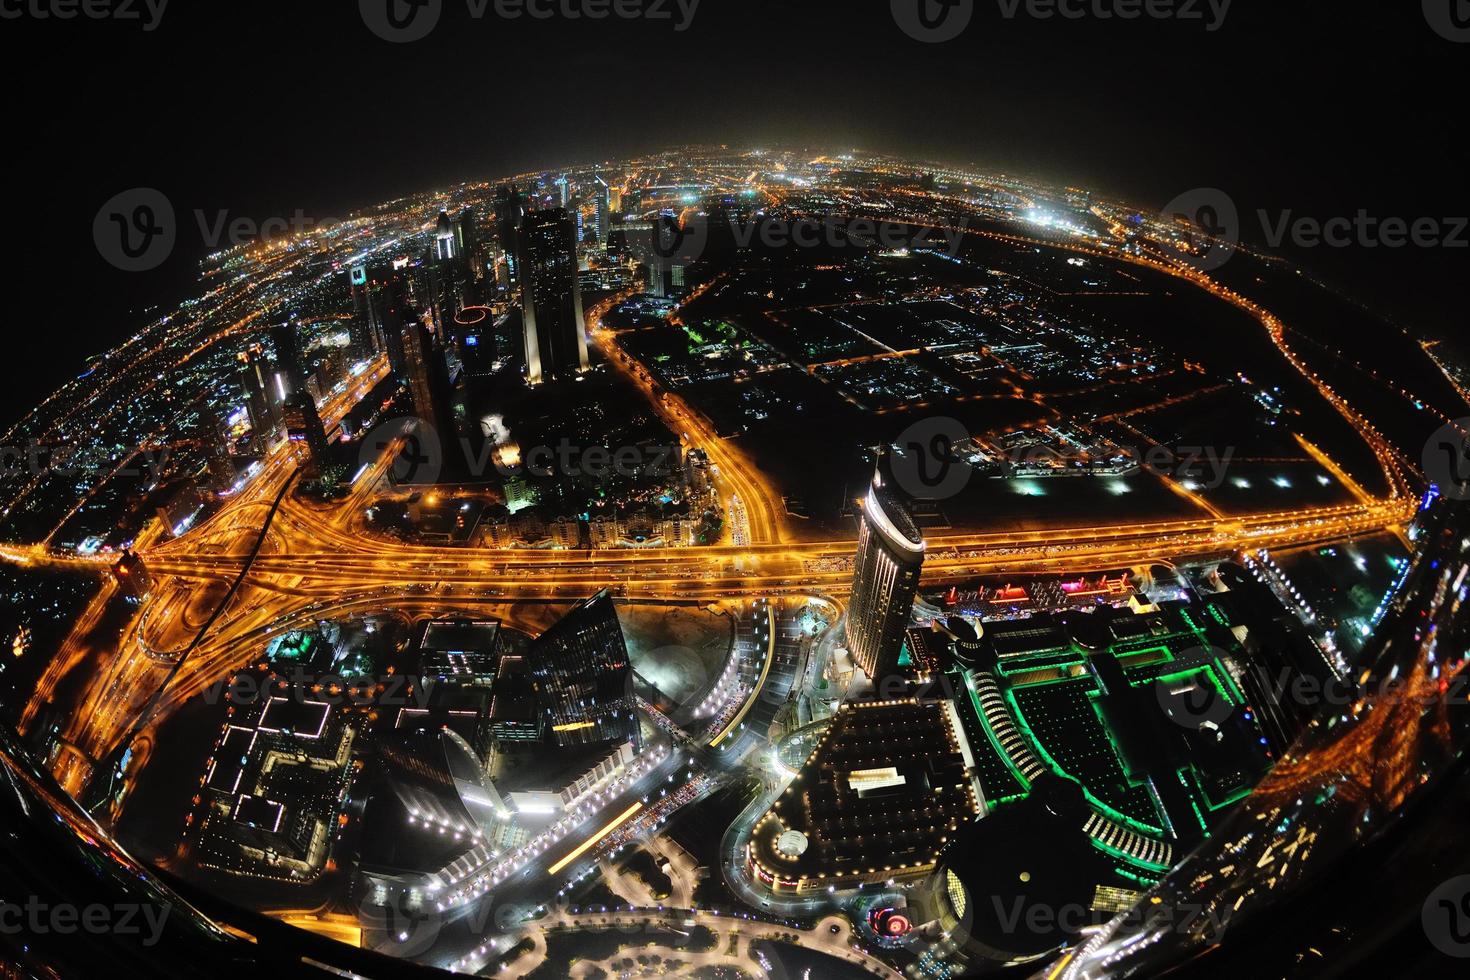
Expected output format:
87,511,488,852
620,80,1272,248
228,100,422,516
520,207,589,385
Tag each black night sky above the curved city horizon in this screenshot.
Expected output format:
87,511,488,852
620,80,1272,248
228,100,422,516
0,0,1470,423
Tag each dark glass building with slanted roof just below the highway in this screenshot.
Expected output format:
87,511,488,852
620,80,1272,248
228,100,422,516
526,589,641,751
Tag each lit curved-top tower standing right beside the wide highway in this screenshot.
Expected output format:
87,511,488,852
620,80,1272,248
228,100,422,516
847,470,925,679
